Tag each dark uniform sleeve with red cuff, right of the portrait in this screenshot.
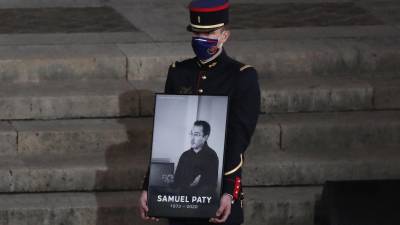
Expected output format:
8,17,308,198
222,67,260,200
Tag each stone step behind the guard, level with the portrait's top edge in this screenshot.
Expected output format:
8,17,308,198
0,77,400,120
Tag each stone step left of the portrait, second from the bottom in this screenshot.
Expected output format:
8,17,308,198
0,151,149,193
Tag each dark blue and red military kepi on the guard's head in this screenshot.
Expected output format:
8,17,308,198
187,0,229,32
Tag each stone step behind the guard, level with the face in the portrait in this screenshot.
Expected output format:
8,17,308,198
0,111,400,155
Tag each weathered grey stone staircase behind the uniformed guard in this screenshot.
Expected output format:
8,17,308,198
0,0,400,225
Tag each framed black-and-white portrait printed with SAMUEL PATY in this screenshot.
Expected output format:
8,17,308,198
148,94,228,218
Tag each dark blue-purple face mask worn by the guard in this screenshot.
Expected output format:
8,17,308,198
192,37,219,61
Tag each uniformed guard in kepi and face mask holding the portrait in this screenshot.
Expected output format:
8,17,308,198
139,0,260,225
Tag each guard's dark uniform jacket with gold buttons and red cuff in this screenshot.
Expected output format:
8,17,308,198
143,48,260,224
